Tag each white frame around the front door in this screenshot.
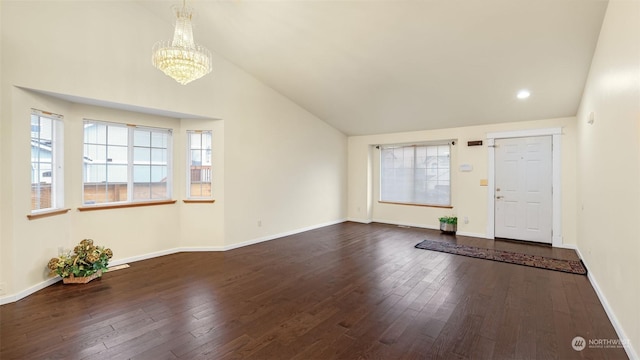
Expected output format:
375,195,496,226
487,128,563,247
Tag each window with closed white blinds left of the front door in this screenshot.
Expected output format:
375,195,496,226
380,144,451,206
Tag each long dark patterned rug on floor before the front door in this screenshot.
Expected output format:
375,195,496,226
416,240,587,275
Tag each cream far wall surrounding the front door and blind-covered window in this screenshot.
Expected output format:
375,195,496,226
348,117,576,246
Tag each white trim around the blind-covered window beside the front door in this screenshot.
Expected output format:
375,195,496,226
376,140,455,209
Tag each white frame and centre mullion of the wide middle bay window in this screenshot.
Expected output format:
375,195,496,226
78,118,176,207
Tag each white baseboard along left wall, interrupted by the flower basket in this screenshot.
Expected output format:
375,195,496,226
0,219,346,305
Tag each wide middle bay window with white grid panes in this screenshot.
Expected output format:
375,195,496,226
83,120,171,205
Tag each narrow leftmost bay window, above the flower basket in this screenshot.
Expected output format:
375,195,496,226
31,110,64,213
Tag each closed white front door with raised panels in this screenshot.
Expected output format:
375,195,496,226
495,136,553,244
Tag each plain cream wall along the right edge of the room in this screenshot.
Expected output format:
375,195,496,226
577,0,640,358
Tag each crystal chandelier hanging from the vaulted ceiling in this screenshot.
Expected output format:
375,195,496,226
151,0,211,85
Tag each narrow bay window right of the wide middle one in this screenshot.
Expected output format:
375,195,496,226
187,130,212,199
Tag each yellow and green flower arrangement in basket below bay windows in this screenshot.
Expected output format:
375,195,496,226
47,239,113,284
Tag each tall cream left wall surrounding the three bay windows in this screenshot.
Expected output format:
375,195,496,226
0,1,347,300
